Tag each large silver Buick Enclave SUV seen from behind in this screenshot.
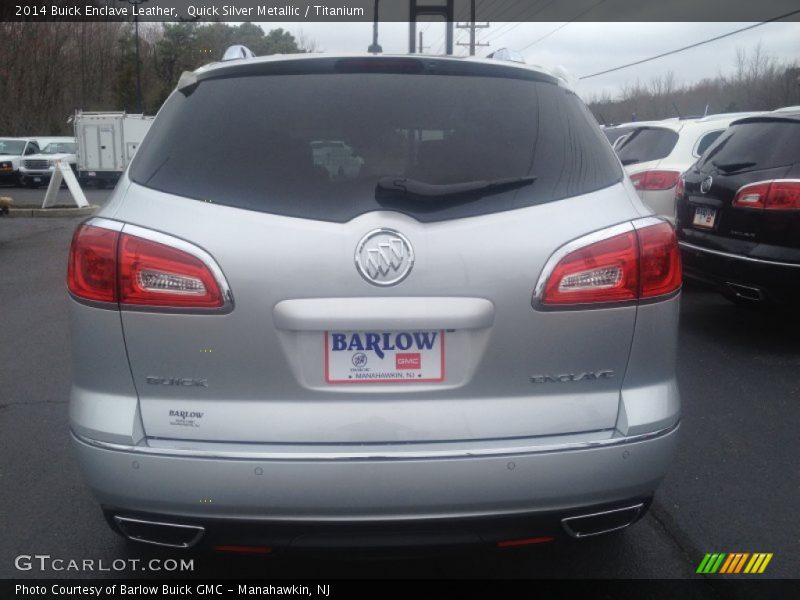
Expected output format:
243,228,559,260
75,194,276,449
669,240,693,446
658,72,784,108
68,55,681,552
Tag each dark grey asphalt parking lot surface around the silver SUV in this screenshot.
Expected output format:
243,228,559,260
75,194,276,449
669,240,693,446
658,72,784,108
0,190,800,578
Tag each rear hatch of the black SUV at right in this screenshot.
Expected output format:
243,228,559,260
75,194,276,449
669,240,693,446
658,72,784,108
678,116,800,255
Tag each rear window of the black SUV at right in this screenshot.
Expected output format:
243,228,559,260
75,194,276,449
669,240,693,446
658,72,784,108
698,120,800,171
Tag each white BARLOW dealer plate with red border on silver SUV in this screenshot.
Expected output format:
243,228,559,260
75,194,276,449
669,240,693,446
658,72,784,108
324,330,445,384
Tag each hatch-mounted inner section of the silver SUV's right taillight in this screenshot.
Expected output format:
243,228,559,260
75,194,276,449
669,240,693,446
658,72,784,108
542,231,639,304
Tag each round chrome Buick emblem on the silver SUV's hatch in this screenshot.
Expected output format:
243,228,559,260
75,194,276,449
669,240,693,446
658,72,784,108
356,229,414,286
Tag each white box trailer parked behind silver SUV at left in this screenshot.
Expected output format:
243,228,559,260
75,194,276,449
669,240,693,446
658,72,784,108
73,110,154,187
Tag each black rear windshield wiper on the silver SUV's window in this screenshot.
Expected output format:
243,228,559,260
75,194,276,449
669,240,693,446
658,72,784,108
375,176,536,204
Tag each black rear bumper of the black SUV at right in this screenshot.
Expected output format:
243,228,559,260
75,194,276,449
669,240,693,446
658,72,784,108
680,241,800,303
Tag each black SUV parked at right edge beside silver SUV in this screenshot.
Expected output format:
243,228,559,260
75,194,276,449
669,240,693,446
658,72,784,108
675,112,800,304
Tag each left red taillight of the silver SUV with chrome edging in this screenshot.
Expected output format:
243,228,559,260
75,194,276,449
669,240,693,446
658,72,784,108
67,221,227,310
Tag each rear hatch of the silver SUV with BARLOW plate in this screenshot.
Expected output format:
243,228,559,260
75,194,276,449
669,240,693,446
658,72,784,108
113,58,638,444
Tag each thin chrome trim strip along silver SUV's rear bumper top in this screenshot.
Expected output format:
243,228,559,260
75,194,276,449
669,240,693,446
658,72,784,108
71,421,680,461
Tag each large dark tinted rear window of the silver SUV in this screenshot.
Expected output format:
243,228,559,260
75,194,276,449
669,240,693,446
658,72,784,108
130,67,622,222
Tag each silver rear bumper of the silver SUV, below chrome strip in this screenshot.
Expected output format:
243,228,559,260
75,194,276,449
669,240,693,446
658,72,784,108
73,423,678,545
